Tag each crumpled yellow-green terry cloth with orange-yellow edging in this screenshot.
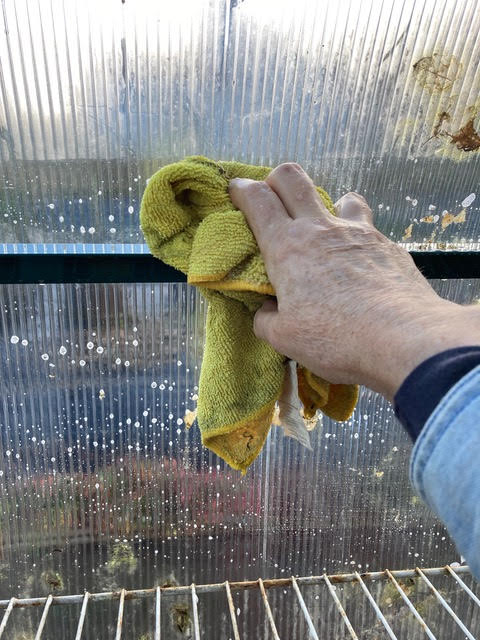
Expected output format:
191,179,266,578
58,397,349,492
140,156,358,473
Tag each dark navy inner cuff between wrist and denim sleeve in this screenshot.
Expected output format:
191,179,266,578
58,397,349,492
393,346,480,442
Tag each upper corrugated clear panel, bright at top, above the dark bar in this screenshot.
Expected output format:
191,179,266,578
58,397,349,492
0,0,480,251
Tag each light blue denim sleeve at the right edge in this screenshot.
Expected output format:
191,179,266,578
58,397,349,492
410,366,480,580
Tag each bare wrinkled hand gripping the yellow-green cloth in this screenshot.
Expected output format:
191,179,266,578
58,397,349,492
230,163,480,399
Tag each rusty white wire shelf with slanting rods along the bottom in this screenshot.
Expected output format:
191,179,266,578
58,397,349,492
0,565,474,640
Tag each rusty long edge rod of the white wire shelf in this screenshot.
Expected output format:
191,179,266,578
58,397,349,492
0,566,471,609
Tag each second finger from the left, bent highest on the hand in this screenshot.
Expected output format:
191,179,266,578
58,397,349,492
265,162,331,218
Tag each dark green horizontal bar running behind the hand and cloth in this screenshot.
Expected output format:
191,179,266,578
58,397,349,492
0,251,480,284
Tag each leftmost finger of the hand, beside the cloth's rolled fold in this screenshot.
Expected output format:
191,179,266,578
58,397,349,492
229,178,289,252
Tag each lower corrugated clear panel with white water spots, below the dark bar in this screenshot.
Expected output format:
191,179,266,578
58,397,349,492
0,281,480,640
